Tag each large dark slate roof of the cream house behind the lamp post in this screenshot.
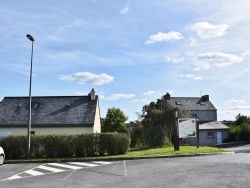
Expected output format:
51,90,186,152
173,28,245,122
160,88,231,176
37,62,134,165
0,96,98,127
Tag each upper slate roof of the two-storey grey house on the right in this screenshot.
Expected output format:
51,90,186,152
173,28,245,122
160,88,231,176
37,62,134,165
169,97,216,111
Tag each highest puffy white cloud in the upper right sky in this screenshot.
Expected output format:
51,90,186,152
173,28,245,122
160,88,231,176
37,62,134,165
192,22,228,39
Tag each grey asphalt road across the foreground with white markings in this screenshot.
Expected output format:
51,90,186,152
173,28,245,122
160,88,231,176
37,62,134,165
0,146,250,188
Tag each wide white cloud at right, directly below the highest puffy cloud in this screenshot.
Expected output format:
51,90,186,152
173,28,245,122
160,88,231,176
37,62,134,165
193,52,243,71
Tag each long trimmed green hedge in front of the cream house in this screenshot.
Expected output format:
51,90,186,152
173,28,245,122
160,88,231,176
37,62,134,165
0,133,129,159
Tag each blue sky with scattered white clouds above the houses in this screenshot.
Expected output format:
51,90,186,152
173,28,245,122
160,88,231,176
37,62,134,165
0,0,250,121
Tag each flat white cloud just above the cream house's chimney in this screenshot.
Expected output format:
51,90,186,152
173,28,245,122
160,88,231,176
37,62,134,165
60,72,114,85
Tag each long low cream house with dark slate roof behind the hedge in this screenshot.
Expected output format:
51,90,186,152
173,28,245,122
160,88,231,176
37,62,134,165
0,89,101,137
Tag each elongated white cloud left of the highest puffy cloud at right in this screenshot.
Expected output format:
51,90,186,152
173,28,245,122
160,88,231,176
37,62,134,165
145,31,184,45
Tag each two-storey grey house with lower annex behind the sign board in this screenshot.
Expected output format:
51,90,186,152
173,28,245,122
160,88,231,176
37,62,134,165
165,93,229,145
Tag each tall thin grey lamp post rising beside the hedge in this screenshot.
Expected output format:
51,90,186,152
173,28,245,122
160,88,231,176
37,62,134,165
26,34,35,159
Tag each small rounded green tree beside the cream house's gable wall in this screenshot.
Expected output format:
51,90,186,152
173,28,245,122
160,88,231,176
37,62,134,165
102,107,128,133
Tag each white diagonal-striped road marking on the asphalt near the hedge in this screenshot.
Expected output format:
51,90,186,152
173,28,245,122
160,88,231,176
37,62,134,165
4,161,119,180
